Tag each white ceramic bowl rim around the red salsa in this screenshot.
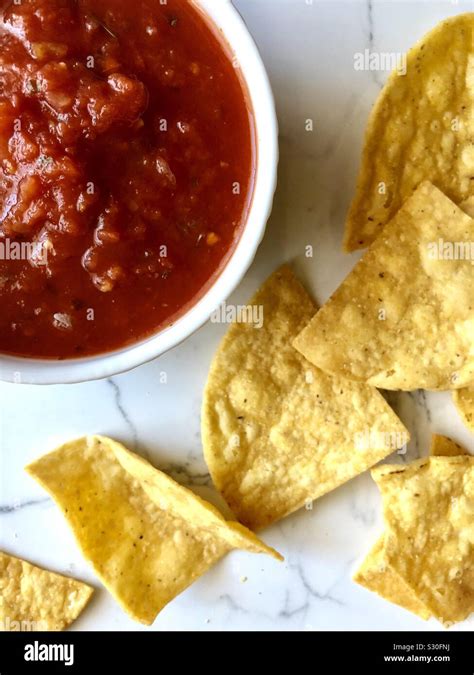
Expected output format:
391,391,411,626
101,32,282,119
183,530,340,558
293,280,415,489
0,0,278,384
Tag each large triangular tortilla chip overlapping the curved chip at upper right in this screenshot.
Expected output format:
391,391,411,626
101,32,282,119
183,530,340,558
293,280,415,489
294,183,474,391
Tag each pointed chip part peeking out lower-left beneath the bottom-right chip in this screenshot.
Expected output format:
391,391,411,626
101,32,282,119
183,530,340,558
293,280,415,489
353,535,431,621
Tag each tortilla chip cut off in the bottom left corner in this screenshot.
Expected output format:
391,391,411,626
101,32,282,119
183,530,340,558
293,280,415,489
0,551,94,631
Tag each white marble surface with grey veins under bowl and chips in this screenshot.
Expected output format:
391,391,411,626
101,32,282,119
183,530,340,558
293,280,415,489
0,0,474,630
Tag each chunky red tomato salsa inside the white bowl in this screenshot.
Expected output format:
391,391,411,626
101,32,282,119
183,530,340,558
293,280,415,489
0,0,254,358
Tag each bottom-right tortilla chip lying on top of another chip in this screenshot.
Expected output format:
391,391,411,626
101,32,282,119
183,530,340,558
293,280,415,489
372,456,474,624
